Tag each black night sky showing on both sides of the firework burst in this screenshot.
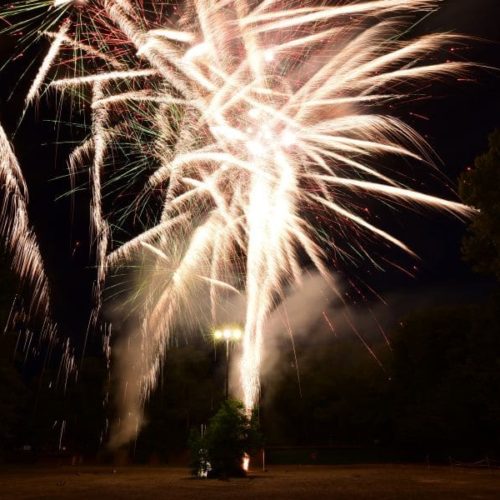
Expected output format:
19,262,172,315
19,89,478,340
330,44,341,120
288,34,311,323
0,0,500,346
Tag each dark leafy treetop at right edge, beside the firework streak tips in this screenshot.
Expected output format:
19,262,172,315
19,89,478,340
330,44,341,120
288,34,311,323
459,129,500,281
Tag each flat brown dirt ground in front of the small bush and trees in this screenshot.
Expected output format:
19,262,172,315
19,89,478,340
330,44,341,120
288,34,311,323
0,465,500,500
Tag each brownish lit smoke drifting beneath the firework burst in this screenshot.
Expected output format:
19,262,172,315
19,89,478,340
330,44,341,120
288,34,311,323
109,260,480,449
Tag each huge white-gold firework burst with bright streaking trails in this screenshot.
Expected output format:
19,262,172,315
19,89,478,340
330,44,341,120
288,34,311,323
0,0,473,438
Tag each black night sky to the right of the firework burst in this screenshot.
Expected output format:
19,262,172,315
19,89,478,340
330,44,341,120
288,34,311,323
384,0,500,292
